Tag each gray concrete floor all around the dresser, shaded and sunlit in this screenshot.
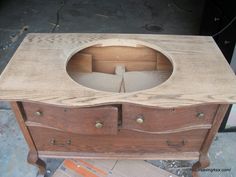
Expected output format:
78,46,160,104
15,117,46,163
0,0,236,177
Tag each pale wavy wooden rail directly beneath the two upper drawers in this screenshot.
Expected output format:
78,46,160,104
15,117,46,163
25,121,211,135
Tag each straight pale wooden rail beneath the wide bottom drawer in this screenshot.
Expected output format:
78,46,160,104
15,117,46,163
38,151,199,160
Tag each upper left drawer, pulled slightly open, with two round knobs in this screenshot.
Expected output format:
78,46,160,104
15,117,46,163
23,103,118,135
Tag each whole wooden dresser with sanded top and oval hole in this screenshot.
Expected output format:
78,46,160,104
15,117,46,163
0,33,236,176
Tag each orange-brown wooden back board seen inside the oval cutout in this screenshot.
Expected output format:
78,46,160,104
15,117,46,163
81,46,172,73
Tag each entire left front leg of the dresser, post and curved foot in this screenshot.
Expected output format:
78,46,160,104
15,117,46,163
11,102,46,175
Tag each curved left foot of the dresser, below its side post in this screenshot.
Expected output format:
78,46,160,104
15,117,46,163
27,151,46,175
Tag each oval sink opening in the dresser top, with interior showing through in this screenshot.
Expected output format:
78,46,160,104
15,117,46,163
66,41,173,93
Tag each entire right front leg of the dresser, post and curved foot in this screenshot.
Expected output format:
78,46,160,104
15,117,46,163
192,105,229,177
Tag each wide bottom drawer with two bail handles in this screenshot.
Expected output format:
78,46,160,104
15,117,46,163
28,127,208,153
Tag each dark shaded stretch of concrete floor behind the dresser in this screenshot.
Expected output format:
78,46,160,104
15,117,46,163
0,0,203,72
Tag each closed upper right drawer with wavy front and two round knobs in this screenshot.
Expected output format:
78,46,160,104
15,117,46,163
122,104,218,133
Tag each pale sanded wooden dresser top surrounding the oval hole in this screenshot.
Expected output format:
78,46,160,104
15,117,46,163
0,33,236,108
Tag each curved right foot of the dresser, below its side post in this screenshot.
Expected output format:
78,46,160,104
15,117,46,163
192,154,210,177
